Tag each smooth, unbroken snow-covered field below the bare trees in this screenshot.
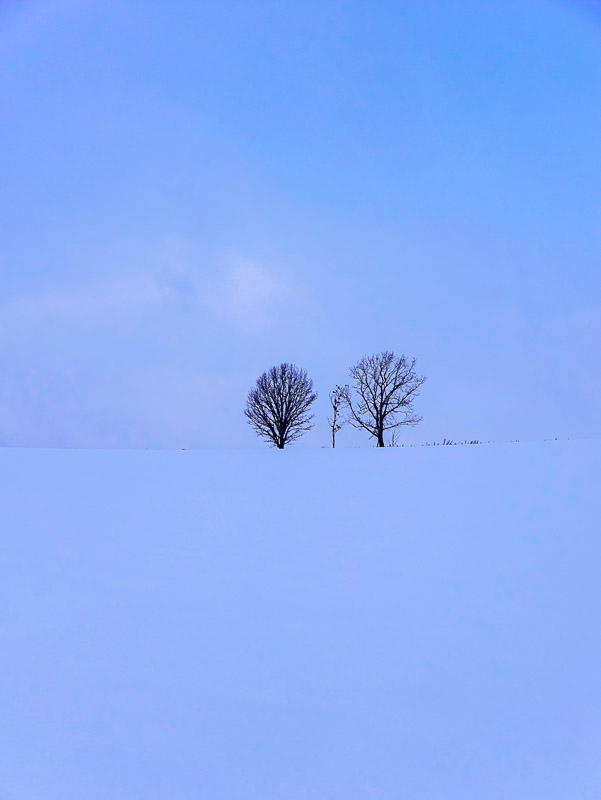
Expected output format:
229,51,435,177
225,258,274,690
0,441,601,800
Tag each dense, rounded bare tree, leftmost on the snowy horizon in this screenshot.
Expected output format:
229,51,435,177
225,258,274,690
244,364,317,450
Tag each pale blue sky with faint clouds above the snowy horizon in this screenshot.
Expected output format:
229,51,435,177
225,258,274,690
0,0,601,447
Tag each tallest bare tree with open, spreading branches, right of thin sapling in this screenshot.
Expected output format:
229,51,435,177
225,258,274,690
344,351,426,447
